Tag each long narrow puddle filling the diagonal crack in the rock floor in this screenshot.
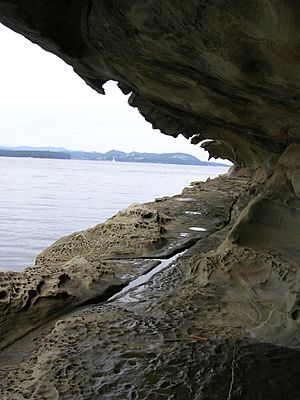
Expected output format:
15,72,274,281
107,250,187,302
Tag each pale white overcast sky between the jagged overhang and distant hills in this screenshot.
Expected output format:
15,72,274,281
0,24,207,160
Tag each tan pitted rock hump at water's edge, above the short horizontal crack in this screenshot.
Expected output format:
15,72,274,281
36,204,169,267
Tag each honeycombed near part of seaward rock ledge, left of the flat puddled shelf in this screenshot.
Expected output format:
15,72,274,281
0,205,169,348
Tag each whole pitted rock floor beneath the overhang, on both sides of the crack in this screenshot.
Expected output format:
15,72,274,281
0,176,300,400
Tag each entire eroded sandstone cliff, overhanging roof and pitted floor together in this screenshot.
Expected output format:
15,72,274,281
0,0,300,400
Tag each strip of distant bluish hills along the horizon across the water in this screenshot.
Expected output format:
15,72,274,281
0,146,228,167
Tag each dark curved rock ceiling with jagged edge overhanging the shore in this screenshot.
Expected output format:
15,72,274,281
0,0,300,168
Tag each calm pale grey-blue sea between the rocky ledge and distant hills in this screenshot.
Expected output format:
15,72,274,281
0,157,227,271
